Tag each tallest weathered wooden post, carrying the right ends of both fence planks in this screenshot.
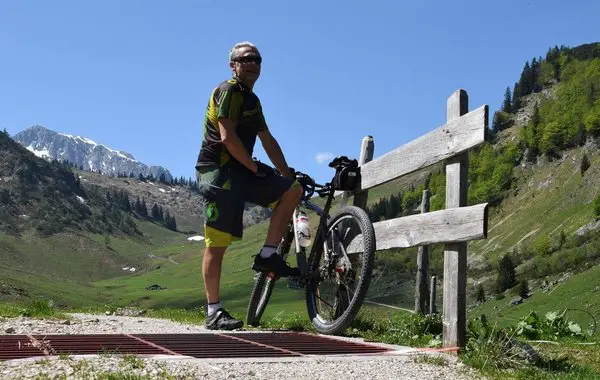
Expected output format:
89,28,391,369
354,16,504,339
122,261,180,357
443,89,469,347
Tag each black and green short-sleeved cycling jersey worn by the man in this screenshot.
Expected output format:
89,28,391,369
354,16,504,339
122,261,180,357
196,78,267,168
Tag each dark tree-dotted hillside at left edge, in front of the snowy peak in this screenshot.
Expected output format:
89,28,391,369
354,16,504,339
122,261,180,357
0,133,143,236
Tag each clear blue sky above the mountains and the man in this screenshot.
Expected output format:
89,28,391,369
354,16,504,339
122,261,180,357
0,0,600,181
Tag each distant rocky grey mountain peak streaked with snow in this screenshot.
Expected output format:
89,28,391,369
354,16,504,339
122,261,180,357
13,125,172,181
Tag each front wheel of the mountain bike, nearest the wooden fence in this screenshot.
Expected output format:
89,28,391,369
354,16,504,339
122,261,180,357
306,206,375,335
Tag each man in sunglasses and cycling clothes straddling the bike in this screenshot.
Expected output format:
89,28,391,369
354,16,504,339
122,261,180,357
196,42,302,330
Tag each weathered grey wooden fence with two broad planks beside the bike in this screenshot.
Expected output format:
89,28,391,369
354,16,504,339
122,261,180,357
342,89,488,348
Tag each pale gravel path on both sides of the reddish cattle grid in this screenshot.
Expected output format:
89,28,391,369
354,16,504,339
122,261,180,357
0,314,486,380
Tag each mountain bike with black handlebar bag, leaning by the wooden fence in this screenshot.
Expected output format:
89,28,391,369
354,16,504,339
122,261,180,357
246,156,375,335
